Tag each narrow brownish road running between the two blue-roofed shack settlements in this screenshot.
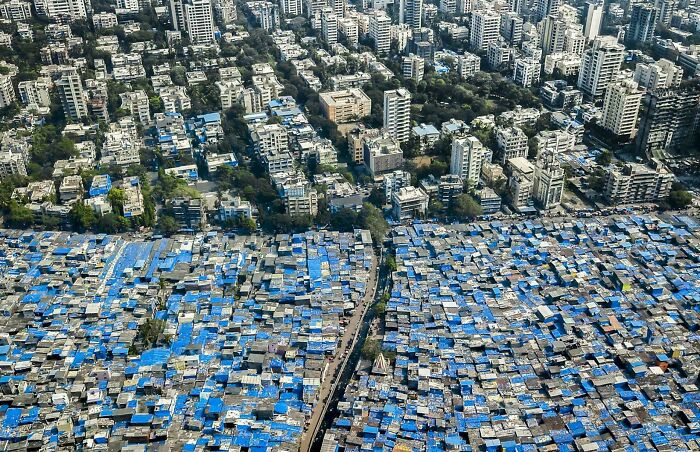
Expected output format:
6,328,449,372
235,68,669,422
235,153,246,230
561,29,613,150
299,251,378,452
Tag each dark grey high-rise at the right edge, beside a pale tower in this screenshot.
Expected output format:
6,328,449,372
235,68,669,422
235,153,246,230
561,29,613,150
637,89,700,158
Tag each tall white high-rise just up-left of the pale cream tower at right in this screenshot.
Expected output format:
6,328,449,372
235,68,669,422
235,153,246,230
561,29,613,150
578,36,625,98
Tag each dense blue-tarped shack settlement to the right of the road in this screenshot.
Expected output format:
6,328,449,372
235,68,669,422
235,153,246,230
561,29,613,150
323,216,700,451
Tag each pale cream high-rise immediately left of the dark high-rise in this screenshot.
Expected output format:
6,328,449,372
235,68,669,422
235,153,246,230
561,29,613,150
602,80,644,138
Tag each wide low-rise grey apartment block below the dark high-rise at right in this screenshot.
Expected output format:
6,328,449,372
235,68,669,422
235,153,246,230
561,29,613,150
605,160,674,204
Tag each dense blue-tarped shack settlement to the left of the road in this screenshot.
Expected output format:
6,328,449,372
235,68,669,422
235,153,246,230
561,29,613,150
0,231,373,450
